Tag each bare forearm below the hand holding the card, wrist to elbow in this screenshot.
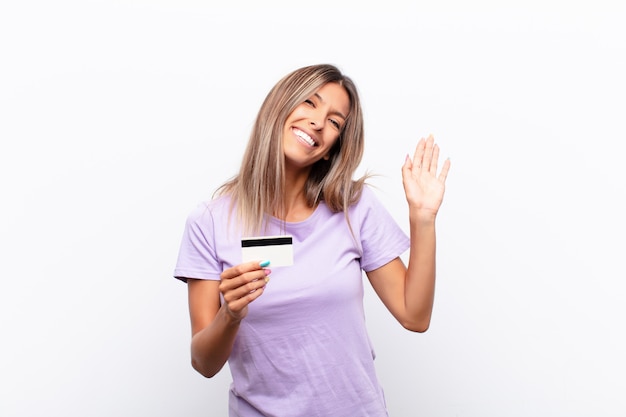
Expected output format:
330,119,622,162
191,306,240,378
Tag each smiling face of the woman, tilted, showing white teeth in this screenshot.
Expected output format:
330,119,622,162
283,82,350,169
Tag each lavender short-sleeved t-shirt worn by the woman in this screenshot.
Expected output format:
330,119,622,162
174,186,409,417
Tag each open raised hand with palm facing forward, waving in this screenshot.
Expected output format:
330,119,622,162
402,135,450,217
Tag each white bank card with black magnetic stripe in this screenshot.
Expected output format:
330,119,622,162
241,236,293,268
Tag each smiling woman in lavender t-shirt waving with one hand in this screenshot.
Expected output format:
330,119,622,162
174,65,450,417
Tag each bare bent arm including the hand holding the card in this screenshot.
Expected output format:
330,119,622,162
187,262,270,378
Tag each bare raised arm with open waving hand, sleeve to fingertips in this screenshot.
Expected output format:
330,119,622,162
367,136,450,332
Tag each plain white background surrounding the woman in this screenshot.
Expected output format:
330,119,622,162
0,0,626,417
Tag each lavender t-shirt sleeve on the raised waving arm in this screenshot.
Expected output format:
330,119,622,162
355,186,410,272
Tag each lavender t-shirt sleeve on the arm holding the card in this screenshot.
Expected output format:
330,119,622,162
174,204,222,282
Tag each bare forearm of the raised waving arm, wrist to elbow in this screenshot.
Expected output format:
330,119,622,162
405,213,436,332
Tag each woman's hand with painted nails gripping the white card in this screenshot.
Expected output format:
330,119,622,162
219,261,272,322
